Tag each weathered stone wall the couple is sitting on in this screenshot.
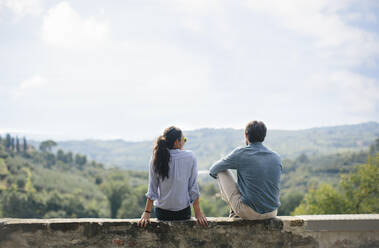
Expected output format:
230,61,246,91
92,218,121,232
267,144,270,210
0,215,379,248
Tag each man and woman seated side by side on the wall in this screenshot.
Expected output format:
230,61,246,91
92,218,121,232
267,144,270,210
138,121,282,227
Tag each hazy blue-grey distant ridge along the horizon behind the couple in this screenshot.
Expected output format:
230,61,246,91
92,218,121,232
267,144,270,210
32,122,379,170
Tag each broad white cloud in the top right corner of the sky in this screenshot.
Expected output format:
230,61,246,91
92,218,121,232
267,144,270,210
248,0,379,66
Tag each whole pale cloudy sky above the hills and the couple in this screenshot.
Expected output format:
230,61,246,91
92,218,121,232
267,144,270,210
0,0,379,141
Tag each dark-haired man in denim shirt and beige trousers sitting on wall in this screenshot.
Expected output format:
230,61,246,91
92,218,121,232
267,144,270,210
209,121,282,220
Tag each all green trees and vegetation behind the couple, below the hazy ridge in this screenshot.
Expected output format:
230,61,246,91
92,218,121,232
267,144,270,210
0,132,379,218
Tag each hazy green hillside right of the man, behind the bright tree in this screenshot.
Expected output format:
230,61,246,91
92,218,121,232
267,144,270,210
279,139,379,215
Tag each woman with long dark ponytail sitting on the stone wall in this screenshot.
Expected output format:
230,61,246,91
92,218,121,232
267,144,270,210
138,127,208,227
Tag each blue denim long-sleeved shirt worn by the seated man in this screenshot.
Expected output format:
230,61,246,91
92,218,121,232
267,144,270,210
209,142,282,214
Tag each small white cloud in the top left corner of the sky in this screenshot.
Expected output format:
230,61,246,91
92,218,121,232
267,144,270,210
0,0,42,18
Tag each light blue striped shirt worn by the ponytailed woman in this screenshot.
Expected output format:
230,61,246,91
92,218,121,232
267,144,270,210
146,149,200,211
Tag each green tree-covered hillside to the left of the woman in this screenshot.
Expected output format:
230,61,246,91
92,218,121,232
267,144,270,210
0,135,147,218
